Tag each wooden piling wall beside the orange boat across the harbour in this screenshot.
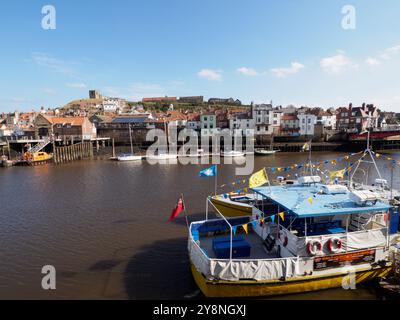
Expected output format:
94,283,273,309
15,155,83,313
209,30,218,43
53,142,93,164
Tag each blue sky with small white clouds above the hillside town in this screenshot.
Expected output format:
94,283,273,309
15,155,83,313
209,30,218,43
0,0,400,112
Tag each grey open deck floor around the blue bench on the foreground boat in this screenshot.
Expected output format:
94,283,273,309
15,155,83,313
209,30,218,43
200,232,277,260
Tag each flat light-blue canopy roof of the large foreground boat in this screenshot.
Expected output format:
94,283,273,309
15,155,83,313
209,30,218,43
252,184,392,218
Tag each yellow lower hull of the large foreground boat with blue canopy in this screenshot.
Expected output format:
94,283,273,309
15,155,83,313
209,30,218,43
191,264,392,298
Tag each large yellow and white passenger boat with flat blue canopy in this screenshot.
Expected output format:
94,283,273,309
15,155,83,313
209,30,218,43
188,176,399,298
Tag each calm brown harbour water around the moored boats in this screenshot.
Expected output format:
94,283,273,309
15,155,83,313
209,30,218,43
0,153,400,299
